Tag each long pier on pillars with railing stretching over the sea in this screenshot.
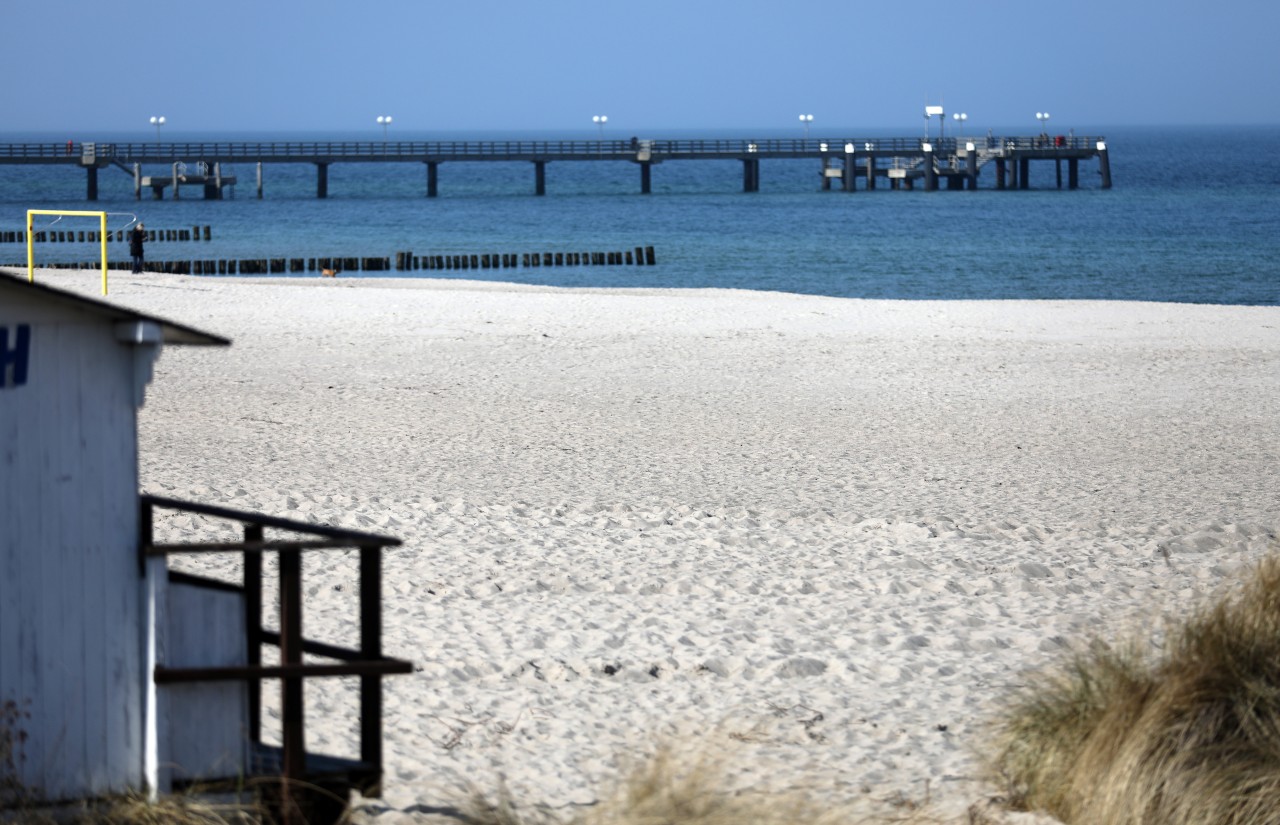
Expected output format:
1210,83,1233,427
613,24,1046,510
0,134,1111,201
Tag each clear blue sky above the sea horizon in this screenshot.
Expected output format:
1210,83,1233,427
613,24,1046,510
0,0,1280,139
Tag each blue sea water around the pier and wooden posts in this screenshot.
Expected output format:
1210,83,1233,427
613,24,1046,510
0,127,1280,306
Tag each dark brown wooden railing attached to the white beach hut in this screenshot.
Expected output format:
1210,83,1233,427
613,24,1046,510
138,495,413,822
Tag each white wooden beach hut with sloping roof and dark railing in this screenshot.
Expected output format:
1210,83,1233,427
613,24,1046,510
0,274,411,820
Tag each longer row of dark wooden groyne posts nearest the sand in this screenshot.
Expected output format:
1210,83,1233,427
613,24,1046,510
17,247,657,275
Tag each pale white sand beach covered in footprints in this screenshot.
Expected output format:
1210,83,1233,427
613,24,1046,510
15,271,1280,825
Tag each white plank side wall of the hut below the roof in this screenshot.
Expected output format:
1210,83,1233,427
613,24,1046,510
0,297,150,799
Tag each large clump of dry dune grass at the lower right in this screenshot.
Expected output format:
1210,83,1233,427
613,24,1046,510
995,558,1280,825
